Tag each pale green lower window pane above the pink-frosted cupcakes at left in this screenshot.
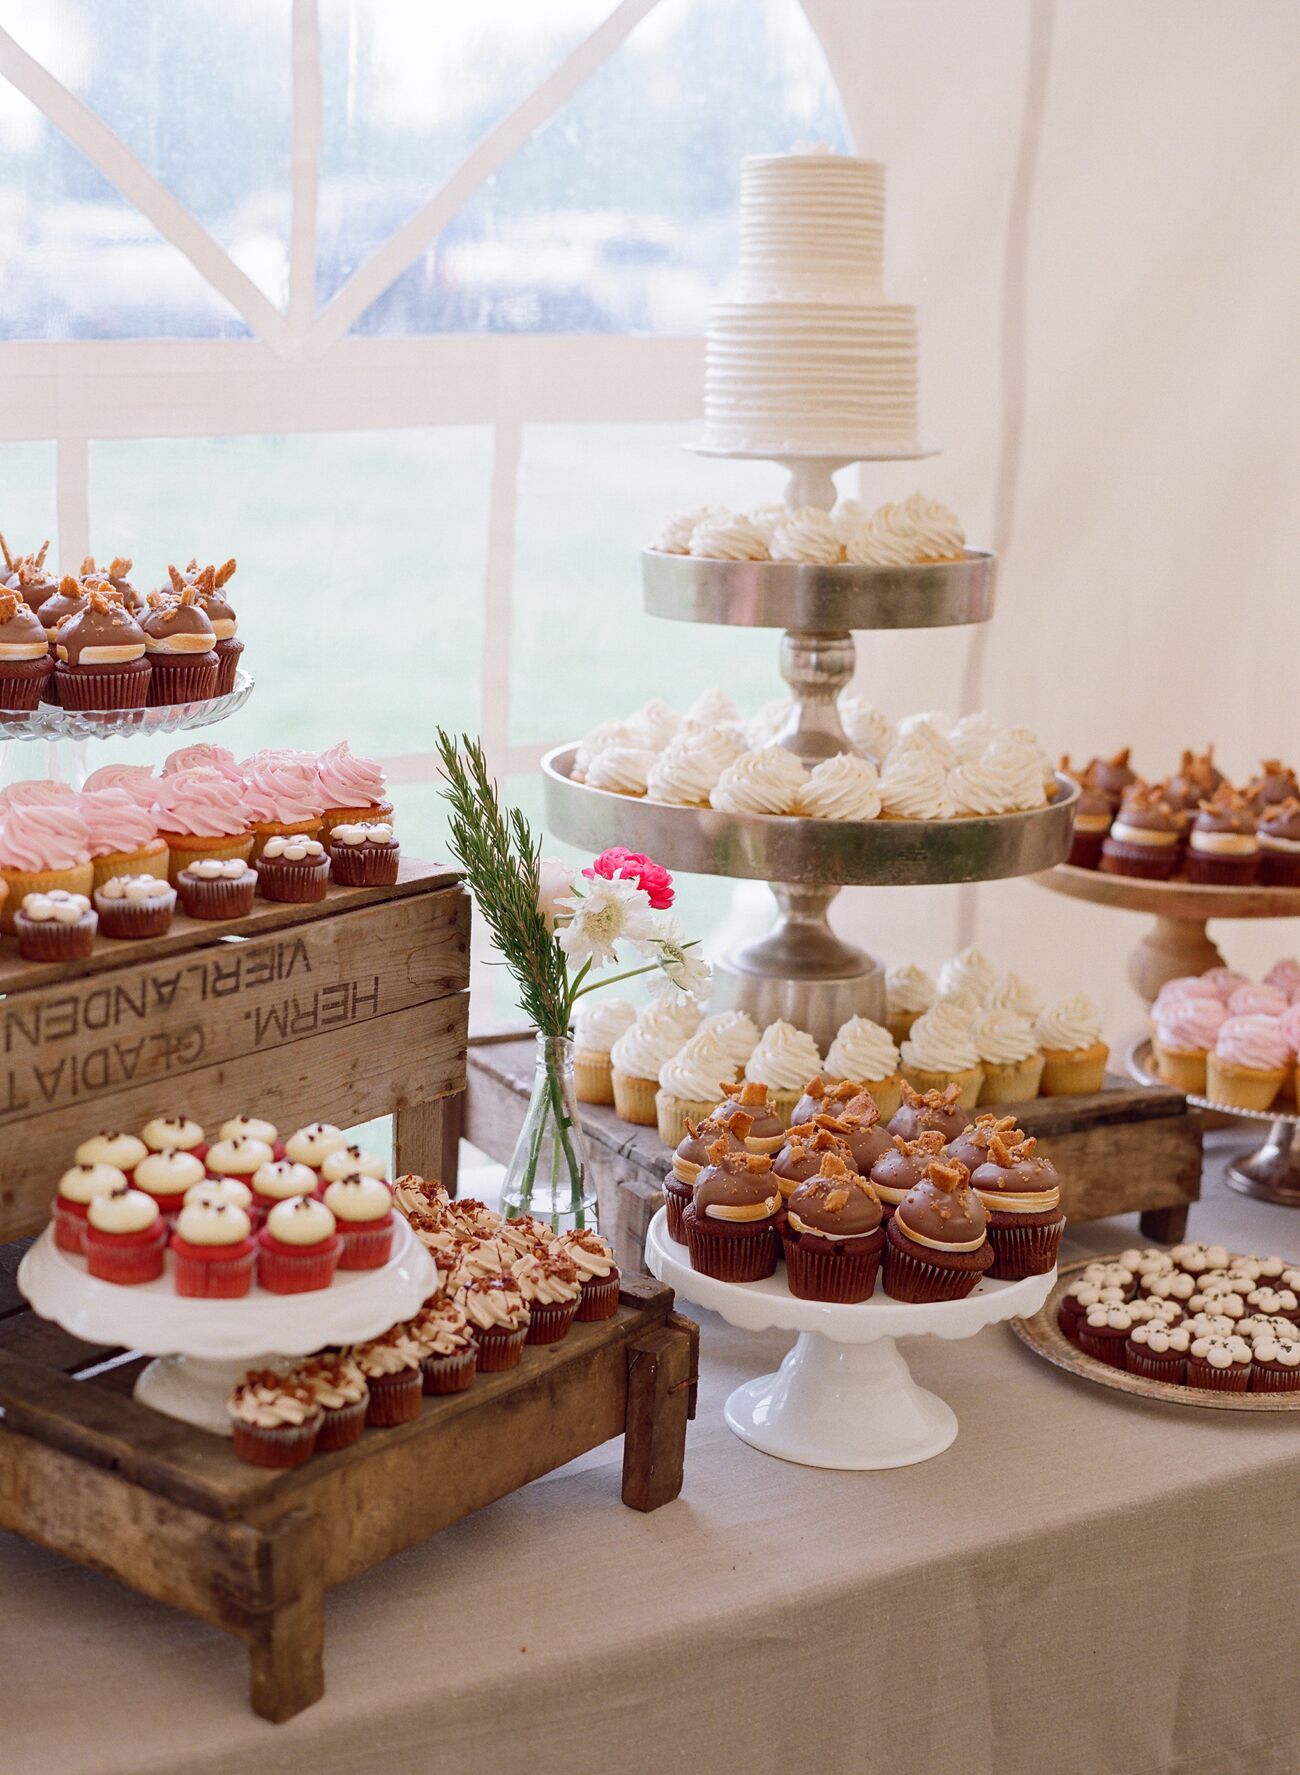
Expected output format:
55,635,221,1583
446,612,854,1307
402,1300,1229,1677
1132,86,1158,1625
91,428,490,758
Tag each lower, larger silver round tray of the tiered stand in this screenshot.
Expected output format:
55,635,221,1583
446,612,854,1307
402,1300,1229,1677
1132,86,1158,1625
542,746,1078,888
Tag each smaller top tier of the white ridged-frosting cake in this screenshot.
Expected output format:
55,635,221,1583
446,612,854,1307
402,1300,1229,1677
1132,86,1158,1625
741,154,884,302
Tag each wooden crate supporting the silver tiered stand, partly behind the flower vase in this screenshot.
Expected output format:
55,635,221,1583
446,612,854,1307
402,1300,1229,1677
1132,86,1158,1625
451,1031,1201,1269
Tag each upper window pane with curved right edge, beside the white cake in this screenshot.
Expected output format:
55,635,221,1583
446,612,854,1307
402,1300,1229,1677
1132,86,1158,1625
344,0,849,334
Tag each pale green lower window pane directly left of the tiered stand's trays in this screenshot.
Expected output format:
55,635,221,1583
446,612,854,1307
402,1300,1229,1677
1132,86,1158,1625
510,426,785,746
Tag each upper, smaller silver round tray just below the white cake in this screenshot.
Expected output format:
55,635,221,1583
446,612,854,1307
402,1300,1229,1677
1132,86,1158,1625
641,548,998,634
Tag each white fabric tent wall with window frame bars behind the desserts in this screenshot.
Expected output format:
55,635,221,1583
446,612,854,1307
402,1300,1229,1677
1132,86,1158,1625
0,0,1300,1037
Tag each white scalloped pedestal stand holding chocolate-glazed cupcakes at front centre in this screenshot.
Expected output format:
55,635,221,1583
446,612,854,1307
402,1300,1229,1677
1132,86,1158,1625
645,1209,1057,1471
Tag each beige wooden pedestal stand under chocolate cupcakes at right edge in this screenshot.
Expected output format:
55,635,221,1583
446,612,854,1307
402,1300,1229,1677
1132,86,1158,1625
1034,863,1300,1005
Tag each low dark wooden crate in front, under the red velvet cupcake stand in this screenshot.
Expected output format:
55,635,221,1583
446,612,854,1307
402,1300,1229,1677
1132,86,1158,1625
0,1246,698,1720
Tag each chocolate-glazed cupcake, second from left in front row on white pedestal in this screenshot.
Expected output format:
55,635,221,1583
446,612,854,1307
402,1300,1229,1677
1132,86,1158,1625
781,1152,884,1303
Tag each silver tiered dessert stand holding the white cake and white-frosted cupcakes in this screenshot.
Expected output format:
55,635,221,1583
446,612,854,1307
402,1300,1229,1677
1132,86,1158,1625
542,449,1078,1051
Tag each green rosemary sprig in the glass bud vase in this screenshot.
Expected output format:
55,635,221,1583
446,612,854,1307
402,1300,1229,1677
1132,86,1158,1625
437,728,572,1035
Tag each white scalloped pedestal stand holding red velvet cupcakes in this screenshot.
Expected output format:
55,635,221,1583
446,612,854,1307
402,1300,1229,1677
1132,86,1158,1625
18,1218,437,1436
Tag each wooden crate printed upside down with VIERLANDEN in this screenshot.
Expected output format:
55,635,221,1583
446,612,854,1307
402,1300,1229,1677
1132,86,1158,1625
0,861,469,1241
